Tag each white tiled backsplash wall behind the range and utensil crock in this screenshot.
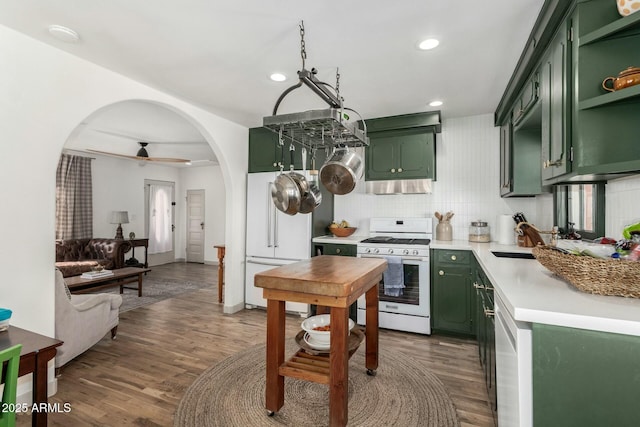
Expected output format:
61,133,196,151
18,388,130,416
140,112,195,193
335,114,553,240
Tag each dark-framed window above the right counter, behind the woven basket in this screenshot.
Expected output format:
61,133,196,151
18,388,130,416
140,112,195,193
554,183,605,239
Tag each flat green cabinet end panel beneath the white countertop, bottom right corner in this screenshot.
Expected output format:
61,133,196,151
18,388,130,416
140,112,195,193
533,324,640,427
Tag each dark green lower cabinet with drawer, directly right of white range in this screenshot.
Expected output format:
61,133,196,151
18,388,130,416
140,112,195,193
431,250,475,336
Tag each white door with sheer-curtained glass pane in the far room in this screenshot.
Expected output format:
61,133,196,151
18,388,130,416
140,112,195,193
144,179,176,266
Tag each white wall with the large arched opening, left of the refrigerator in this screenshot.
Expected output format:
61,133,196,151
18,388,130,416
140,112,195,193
0,26,248,336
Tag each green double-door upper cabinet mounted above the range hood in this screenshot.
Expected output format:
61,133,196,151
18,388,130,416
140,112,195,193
365,111,440,181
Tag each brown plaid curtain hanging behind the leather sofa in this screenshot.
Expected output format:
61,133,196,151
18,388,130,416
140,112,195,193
56,154,93,239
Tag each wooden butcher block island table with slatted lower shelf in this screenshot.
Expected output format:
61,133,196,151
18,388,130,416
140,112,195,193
255,255,387,426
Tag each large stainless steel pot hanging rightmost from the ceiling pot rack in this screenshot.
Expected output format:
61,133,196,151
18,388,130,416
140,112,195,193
320,147,363,195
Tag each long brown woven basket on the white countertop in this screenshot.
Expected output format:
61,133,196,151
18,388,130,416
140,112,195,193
532,246,640,298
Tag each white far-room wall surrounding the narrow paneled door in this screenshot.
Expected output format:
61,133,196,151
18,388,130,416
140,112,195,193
176,166,226,264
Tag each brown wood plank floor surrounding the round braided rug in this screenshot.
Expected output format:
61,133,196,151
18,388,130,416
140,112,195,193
18,263,494,427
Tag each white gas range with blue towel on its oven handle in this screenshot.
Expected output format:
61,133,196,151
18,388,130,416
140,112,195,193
357,218,432,334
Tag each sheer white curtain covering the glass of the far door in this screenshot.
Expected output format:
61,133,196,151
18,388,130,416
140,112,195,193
149,184,173,254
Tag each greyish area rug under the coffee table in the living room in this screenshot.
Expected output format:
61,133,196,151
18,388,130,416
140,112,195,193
100,277,216,313
